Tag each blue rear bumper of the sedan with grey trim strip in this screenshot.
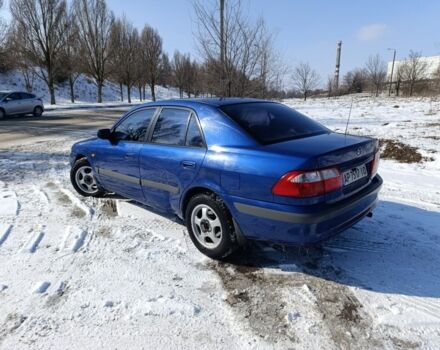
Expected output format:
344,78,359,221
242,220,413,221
228,175,383,245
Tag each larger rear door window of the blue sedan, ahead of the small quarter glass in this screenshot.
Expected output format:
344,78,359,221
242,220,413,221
151,108,191,146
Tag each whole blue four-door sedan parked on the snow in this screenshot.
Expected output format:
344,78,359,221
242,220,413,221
71,98,382,259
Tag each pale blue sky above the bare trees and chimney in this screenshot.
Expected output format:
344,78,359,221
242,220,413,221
3,0,440,87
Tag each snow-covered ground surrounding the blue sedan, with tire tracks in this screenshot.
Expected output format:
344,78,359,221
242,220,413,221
0,97,440,349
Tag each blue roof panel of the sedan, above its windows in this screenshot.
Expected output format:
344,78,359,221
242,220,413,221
138,97,271,107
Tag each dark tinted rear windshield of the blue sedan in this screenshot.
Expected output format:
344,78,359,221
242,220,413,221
220,102,329,145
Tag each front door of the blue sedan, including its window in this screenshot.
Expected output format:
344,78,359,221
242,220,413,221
94,108,157,202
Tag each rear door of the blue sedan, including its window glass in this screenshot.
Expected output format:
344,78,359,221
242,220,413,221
140,107,206,211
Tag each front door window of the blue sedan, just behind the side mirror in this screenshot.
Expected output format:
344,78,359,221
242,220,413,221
113,108,156,141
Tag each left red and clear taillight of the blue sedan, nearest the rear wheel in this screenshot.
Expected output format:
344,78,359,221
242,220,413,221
272,168,342,197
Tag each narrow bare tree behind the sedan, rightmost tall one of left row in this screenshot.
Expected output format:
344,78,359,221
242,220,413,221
140,25,162,101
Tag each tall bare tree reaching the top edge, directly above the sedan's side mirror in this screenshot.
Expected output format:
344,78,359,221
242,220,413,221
73,0,114,102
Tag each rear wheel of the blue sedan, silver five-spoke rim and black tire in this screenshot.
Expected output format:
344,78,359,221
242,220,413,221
185,193,238,260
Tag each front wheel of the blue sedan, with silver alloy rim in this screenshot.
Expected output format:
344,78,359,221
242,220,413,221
70,158,105,197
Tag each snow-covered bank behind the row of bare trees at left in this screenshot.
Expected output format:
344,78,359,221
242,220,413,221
0,70,179,109
